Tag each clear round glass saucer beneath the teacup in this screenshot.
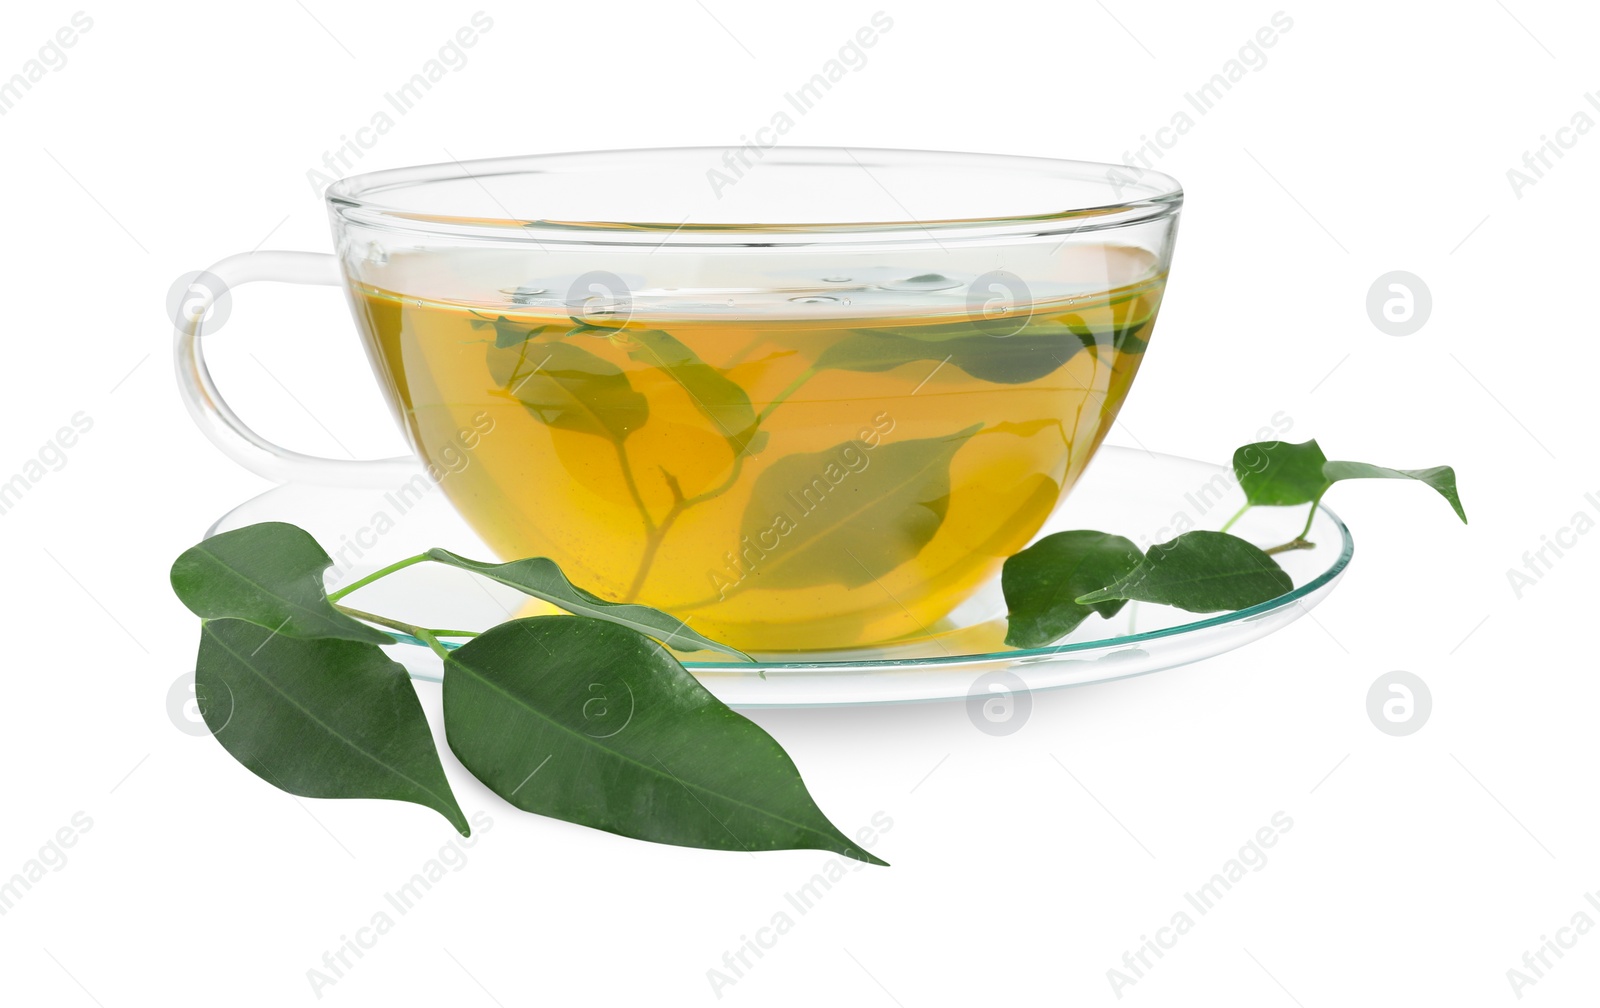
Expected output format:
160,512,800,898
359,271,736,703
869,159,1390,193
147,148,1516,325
208,445,1355,707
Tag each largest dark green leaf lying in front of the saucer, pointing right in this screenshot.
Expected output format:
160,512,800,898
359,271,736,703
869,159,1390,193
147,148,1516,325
445,616,883,864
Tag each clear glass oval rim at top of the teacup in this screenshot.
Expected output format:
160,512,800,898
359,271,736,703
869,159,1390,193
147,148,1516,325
326,146,1182,248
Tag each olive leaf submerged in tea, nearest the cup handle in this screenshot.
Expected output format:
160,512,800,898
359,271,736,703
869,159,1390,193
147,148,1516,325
490,341,650,442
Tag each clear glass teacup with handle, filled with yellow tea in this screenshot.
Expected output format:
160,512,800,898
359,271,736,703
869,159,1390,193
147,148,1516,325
179,147,1182,651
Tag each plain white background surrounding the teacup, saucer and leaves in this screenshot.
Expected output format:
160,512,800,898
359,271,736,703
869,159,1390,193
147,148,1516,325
0,0,1600,1008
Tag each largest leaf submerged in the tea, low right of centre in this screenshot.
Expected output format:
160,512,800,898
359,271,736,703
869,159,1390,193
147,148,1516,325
741,424,982,589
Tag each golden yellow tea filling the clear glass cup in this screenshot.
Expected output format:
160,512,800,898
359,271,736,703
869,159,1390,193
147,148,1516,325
355,248,1165,651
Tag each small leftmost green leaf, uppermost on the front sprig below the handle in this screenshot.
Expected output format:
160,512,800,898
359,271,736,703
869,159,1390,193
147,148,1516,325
171,522,394,643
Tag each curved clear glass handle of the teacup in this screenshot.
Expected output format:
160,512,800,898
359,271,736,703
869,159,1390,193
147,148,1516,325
173,251,421,486
